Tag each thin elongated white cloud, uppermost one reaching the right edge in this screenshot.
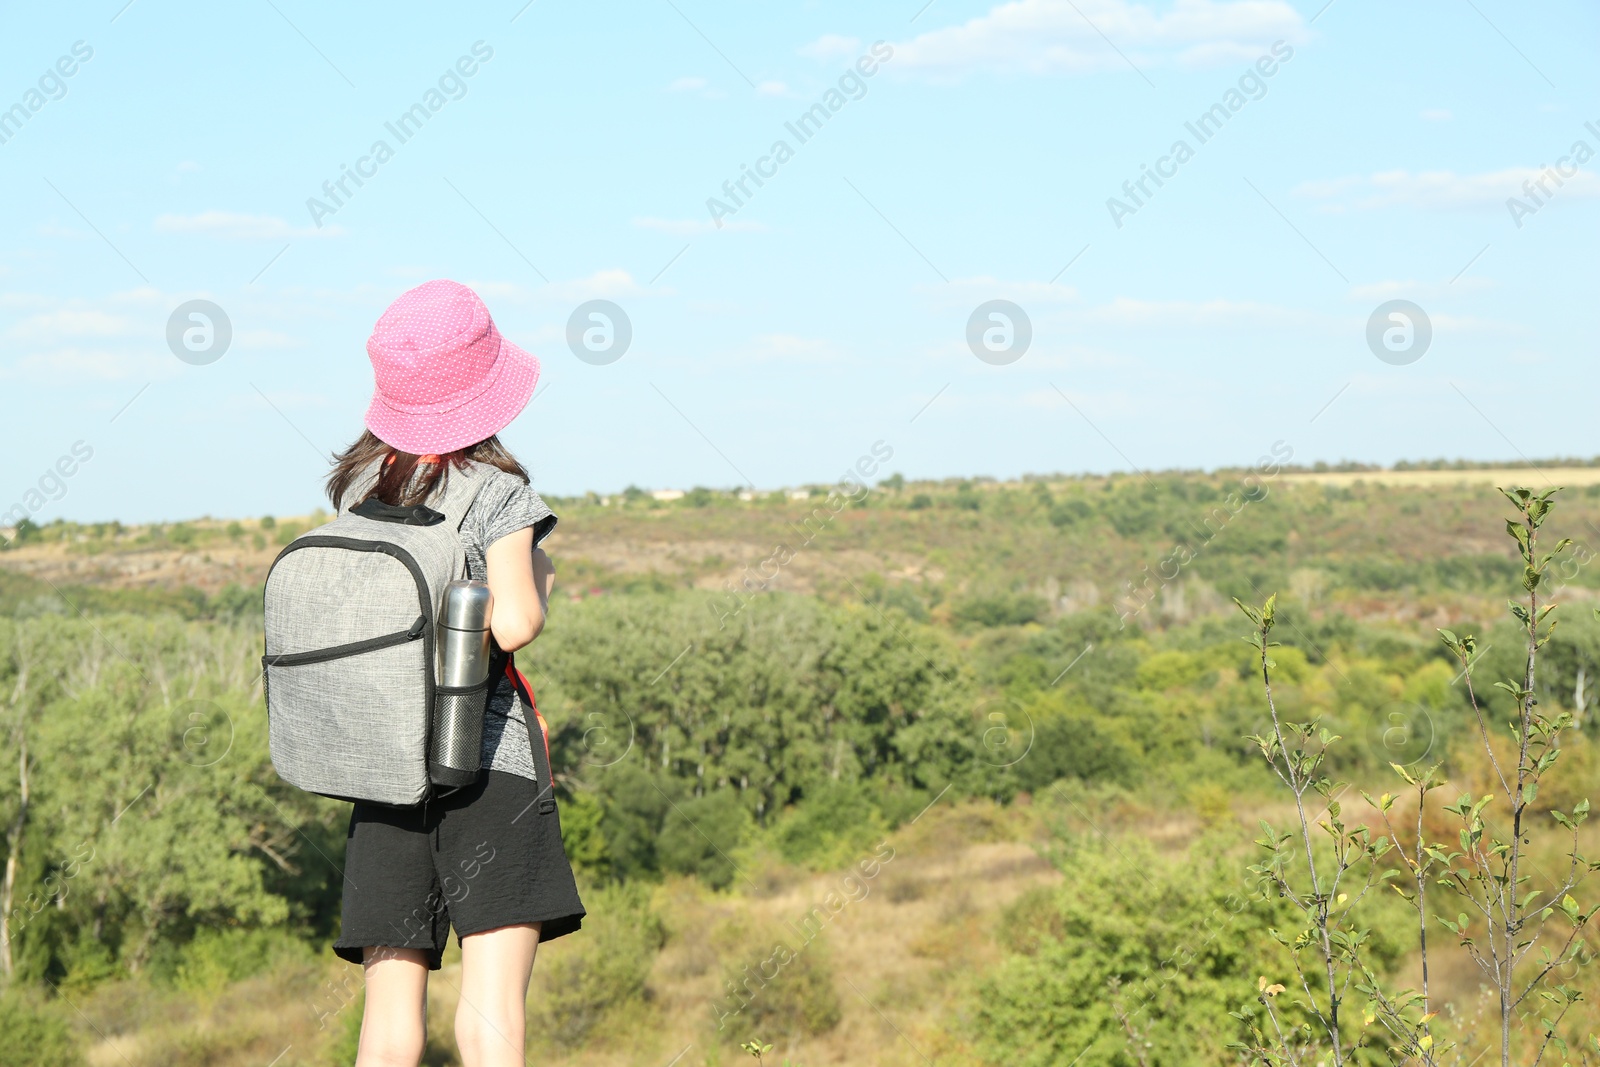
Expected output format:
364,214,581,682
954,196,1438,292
1294,166,1600,211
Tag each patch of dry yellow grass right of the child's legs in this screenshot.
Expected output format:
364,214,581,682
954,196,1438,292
505,803,1059,1067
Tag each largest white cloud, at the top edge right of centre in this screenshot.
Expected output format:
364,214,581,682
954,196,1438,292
886,0,1307,77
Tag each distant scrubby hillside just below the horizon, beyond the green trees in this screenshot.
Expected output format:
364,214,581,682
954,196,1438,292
9,467,1600,622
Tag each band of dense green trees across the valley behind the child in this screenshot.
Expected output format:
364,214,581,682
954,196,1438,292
9,575,1600,982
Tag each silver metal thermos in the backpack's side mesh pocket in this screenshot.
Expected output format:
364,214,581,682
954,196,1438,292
427,581,494,785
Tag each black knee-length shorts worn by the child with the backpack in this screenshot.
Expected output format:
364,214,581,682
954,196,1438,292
333,771,584,969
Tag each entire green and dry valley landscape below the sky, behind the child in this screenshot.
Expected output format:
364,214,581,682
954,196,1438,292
0,466,1600,1067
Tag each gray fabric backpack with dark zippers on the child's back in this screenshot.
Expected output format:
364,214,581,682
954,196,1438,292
261,462,496,805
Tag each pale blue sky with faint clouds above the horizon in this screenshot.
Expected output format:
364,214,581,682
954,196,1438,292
0,0,1600,522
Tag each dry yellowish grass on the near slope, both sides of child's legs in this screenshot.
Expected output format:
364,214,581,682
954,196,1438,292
75,801,1059,1067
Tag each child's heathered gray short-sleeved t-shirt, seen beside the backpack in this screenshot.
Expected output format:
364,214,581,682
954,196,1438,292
461,470,555,781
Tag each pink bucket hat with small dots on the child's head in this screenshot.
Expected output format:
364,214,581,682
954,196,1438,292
366,280,539,456
